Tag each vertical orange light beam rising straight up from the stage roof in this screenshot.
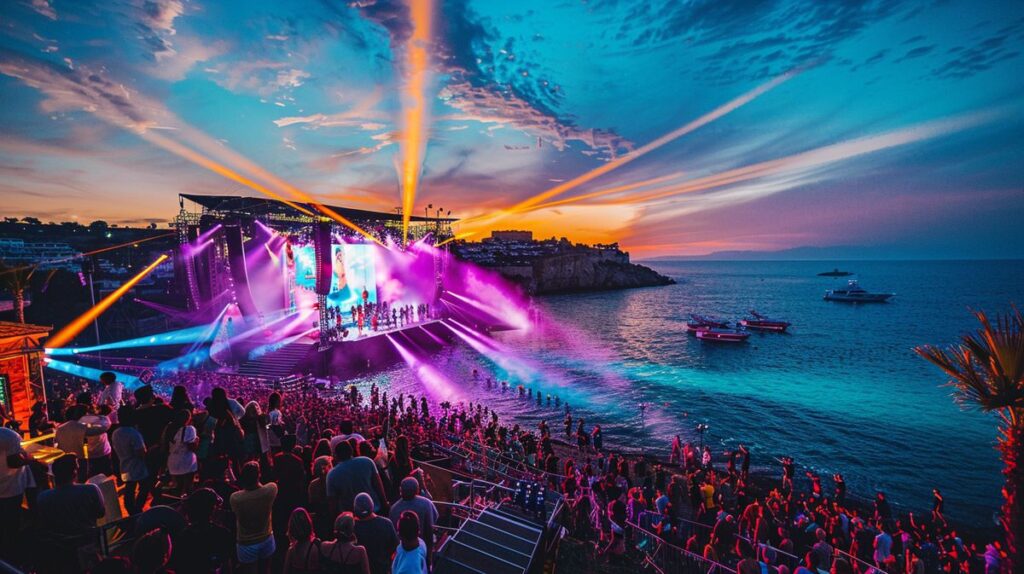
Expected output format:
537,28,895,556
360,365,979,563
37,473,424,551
400,0,433,244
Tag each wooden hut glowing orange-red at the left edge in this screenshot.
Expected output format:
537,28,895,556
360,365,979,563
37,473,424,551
0,321,52,430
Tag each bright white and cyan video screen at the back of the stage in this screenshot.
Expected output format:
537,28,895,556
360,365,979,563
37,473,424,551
292,244,377,311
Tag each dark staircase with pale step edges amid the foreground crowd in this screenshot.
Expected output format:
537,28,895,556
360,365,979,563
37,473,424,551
434,504,544,574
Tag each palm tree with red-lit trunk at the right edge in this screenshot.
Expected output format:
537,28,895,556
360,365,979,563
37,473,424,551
914,308,1024,572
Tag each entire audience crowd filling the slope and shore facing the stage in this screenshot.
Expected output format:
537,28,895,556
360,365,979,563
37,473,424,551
0,366,1000,574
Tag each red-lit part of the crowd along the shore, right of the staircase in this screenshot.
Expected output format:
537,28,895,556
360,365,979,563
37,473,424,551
548,429,1005,574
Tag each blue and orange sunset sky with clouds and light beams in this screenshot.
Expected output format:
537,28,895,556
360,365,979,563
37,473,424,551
0,0,1024,258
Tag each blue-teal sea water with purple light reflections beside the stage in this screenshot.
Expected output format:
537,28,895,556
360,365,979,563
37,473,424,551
350,261,1024,525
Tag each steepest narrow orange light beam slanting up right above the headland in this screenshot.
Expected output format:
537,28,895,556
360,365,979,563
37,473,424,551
464,70,800,222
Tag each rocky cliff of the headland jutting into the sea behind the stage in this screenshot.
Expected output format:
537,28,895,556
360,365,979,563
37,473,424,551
494,250,676,294
